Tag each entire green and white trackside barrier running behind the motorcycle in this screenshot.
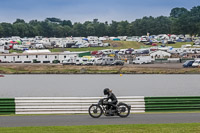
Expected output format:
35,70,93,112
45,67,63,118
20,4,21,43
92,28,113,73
0,96,200,114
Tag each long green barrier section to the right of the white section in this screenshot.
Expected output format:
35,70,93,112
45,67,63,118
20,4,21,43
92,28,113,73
145,96,200,112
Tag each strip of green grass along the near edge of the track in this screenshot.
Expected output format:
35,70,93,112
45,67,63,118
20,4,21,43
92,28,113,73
0,123,200,133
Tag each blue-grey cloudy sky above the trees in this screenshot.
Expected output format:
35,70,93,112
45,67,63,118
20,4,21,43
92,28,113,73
0,0,200,23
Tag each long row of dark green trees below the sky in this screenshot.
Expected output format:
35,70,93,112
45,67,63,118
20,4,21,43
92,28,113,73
0,6,200,37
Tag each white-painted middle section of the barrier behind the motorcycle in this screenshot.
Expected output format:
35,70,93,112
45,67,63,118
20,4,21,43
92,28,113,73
15,96,145,114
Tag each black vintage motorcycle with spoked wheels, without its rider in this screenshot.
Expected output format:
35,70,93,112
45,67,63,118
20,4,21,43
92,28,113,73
88,98,131,118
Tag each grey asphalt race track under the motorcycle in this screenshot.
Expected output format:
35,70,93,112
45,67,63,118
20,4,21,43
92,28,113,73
0,113,200,127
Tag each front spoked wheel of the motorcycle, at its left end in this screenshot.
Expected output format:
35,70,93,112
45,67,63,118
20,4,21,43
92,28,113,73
88,105,103,118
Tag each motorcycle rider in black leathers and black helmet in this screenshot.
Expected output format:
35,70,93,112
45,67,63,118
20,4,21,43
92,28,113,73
103,88,118,110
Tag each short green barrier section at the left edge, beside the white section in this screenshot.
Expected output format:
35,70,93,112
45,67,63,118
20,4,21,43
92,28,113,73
0,98,15,115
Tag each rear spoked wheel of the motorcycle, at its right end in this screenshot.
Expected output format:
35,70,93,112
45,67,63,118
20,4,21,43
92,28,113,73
118,104,130,117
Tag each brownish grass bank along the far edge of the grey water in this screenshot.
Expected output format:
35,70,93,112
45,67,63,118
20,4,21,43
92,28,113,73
0,64,200,74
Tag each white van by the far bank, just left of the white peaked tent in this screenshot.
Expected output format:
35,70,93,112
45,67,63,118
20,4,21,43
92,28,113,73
133,56,153,64
